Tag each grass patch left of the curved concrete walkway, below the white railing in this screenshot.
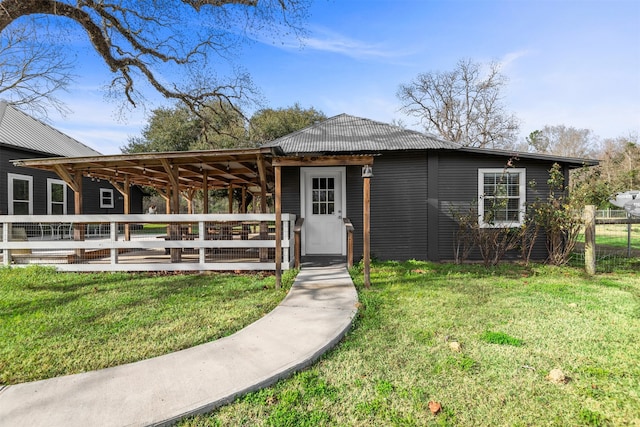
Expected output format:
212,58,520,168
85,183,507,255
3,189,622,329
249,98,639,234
0,267,294,384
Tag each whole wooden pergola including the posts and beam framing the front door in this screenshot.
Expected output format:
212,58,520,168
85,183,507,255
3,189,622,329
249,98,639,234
13,147,373,285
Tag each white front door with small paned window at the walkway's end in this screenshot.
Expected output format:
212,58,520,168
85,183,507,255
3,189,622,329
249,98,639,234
300,167,346,255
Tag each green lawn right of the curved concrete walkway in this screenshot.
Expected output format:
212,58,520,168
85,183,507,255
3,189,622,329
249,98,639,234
180,262,640,427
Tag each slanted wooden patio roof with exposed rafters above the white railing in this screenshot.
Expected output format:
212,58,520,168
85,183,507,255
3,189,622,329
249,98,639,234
14,148,273,215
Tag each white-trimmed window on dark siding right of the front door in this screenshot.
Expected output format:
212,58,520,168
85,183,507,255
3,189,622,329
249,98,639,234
478,168,527,228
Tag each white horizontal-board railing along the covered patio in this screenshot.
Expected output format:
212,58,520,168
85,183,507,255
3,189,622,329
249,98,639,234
0,214,296,271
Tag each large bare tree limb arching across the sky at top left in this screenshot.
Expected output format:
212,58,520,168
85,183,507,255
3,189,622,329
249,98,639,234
0,0,308,119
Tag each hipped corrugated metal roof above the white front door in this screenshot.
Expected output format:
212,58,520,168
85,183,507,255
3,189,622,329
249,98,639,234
264,114,461,154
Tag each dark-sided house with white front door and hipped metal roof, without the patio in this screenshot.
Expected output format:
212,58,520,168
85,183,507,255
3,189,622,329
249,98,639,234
265,114,595,261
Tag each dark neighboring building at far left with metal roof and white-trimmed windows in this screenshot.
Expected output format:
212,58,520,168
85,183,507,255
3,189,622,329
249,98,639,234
0,102,142,221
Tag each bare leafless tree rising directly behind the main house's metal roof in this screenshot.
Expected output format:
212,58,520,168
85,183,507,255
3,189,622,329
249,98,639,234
397,59,519,148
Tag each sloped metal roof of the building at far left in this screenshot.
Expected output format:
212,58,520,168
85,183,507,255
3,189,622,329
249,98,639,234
0,101,100,157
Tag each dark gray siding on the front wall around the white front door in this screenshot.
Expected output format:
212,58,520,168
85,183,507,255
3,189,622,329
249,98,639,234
282,150,572,261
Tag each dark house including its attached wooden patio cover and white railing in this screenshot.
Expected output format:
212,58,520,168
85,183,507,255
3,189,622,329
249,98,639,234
3,114,596,277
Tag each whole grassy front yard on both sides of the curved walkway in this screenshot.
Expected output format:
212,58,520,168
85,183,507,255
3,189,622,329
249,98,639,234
0,261,640,427
